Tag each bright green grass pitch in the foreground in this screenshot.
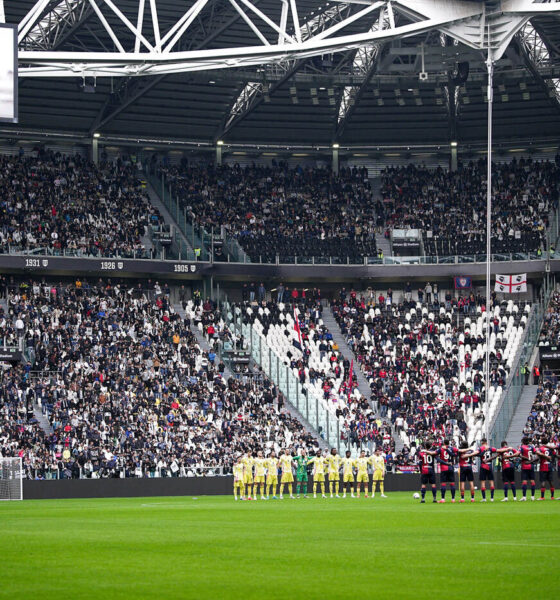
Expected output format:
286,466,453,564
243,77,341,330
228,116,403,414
0,493,560,600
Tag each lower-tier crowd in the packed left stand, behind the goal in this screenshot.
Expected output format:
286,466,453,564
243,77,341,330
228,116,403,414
0,280,316,478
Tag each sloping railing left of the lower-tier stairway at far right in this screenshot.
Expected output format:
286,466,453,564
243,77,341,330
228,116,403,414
489,277,555,446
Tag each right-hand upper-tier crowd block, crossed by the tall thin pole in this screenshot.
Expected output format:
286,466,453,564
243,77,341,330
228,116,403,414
381,159,560,256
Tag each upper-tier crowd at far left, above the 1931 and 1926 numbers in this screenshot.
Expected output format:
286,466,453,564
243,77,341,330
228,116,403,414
0,150,161,258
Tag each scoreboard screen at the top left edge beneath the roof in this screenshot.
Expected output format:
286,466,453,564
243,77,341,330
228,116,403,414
0,24,18,123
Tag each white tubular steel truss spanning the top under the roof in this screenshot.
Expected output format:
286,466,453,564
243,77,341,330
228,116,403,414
14,0,560,77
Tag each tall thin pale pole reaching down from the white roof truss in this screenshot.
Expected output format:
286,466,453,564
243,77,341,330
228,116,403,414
484,44,494,441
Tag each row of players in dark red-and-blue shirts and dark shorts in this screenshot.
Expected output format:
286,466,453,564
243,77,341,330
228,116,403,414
418,437,560,503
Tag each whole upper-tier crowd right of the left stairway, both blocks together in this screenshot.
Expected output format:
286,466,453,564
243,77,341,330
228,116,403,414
156,158,559,262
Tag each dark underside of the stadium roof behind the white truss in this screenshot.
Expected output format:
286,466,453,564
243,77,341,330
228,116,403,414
2,0,560,146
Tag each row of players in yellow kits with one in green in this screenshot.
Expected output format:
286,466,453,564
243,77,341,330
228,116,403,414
233,448,386,500
